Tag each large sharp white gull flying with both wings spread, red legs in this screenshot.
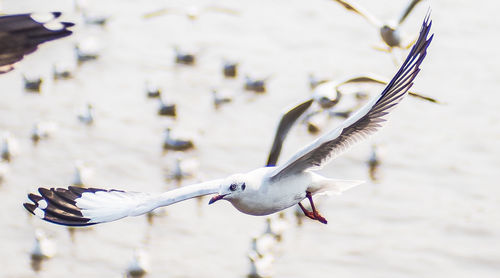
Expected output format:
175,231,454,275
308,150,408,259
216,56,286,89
24,15,433,226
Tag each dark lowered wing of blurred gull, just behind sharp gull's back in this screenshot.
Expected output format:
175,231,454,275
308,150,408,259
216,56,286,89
266,99,313,167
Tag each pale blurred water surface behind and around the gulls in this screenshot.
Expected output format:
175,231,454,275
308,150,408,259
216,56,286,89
0,0,500,277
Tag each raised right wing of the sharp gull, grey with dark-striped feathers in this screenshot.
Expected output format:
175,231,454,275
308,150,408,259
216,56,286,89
269,15,434,180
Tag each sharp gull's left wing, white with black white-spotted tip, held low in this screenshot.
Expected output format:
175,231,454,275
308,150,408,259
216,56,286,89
24,180,221,226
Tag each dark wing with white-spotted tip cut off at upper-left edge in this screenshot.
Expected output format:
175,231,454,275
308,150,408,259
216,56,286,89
0,12,73,73
